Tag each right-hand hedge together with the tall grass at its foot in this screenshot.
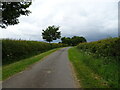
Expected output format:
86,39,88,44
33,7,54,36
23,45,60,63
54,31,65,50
77,38,120,88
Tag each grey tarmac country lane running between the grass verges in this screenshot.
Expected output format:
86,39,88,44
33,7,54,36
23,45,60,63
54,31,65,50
2,47,76,88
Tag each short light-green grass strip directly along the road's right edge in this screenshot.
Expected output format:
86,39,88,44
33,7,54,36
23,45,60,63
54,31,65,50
68,48,108,88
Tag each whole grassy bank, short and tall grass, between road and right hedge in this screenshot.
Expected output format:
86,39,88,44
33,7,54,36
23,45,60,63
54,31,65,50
68,48,120,88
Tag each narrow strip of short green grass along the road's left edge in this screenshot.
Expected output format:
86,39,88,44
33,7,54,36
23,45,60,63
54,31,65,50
2,48,60,80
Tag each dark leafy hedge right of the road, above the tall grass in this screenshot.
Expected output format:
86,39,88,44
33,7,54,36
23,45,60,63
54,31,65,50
77,38,120,61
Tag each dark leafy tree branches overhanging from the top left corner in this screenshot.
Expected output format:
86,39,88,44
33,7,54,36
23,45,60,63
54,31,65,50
0,2,31,28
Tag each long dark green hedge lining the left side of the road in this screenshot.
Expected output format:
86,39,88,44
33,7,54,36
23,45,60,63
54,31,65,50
2,39,66,65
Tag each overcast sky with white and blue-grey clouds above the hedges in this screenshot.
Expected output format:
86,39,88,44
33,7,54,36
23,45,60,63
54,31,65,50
0,0,119,41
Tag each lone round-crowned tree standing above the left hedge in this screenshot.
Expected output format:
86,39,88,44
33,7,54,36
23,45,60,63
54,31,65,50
42,25,61,43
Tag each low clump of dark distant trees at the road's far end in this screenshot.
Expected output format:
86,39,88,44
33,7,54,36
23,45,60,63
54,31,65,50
61,36,87,46
